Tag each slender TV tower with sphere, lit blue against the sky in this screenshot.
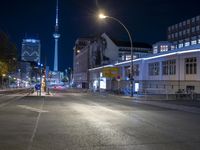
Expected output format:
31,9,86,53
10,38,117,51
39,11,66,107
53,0,60,71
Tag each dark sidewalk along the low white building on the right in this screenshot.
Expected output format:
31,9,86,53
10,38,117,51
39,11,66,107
111,95,200,114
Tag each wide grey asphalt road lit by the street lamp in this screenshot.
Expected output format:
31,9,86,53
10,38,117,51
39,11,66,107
0,93,200,150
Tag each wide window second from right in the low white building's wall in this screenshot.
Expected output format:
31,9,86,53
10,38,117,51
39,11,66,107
162,59,176,75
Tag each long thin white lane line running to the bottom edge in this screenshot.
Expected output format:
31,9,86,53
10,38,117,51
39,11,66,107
28,97,45,150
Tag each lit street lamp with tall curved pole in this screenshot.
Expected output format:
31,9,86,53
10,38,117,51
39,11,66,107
98,13,134,97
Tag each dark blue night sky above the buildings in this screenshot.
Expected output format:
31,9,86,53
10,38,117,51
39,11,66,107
0,0,200,70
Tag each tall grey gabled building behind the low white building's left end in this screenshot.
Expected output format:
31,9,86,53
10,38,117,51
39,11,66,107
73,33,152,88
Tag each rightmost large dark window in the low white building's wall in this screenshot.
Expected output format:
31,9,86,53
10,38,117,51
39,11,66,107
185,57,197,74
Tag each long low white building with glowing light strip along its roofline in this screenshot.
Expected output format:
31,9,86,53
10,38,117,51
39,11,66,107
89,44,200,94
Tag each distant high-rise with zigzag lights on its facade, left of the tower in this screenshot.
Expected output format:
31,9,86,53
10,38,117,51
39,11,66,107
21,38,41,63
